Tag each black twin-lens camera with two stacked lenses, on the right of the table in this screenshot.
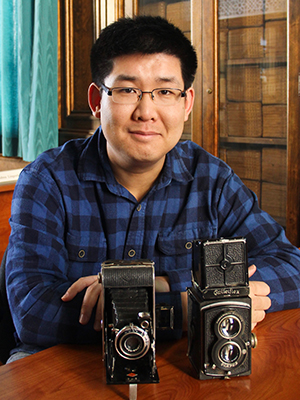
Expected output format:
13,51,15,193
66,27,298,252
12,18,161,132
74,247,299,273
188,238,256,380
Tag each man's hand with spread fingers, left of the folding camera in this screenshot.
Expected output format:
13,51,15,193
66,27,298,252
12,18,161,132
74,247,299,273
61,275,103,331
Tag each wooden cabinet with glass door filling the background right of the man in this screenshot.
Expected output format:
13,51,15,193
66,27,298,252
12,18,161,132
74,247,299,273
135,0,300,246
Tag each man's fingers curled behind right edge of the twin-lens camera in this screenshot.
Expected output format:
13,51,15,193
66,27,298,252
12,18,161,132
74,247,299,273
248,265,271,329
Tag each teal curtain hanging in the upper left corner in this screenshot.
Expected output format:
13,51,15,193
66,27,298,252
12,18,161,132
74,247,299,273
0,0,58,161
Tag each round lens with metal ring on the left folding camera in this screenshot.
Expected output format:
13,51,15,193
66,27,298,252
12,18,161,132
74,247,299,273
115,324,150,360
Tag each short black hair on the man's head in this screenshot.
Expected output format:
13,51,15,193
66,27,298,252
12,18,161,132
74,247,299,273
91,16,197,90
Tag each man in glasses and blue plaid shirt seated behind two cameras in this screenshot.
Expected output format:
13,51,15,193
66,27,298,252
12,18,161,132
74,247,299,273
7,17,300,357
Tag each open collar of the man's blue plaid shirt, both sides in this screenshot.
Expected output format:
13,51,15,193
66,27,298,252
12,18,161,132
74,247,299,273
78,128,193,188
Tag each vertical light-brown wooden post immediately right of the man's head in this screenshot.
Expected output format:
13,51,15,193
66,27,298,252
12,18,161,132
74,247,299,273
191,0,219,156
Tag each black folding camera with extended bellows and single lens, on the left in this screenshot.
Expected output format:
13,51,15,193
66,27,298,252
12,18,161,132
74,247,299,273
101,260,159,384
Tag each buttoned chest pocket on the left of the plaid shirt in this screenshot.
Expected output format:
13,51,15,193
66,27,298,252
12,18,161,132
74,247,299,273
66,232,107,263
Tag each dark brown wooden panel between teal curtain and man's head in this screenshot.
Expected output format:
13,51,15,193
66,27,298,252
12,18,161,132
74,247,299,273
59,0,100,143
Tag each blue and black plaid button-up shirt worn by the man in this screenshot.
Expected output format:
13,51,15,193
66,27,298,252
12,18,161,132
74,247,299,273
7,129,300,351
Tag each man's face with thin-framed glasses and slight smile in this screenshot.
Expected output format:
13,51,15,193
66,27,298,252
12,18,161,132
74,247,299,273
92,53,194,172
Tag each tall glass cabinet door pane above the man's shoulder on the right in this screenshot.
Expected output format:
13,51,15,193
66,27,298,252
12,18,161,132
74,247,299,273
218,0,288,227
